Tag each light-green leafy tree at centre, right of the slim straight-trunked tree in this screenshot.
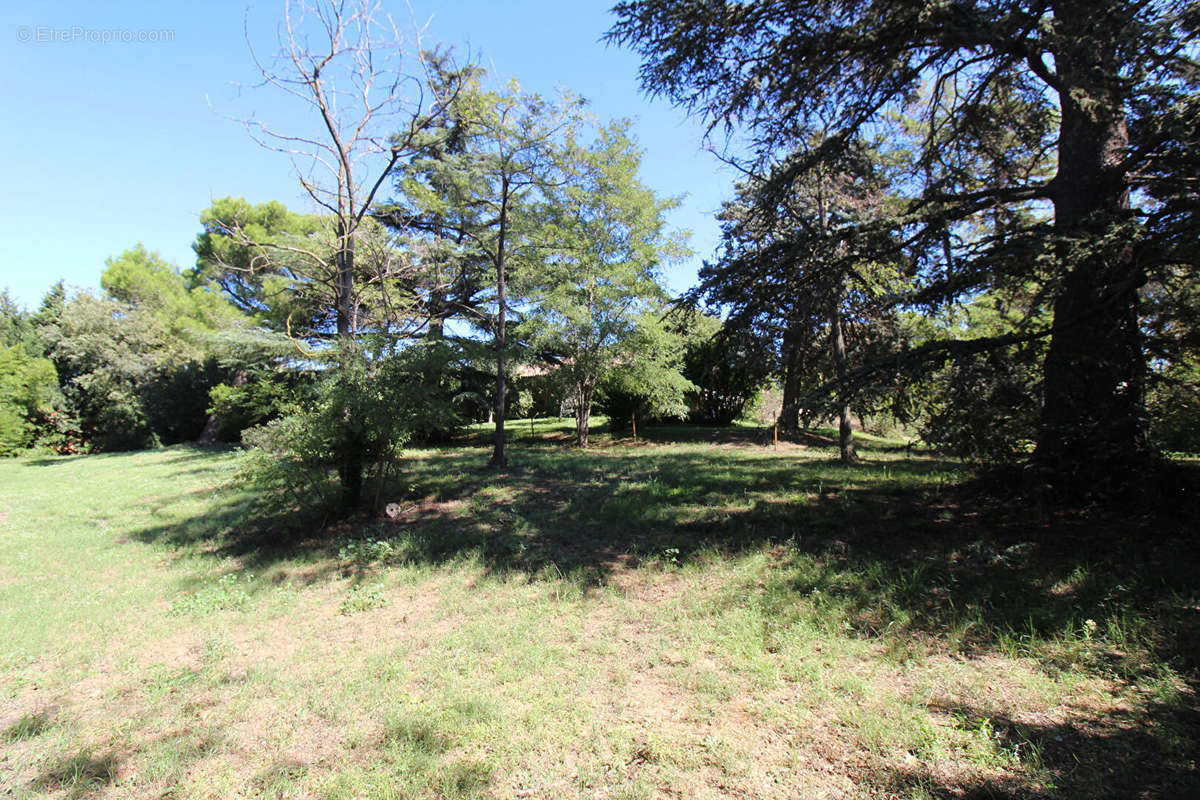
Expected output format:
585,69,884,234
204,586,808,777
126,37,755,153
527,122,688,447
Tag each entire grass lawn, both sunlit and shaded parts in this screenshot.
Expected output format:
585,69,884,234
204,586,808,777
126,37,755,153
0,421,1200,800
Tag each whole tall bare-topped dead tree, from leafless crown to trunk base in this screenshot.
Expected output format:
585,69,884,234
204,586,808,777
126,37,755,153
210,0,456,513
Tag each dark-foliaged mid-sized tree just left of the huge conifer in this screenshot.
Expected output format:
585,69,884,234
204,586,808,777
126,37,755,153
694,139,901,463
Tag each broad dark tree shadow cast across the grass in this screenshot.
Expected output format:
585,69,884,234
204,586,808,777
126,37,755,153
114,432,1200,798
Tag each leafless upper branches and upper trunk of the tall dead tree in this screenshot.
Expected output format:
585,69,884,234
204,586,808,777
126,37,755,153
234,0,449,341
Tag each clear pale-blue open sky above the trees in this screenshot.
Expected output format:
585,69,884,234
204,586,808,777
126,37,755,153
0,0,731,307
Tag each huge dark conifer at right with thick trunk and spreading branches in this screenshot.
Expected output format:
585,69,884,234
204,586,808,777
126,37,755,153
610,0,1200,487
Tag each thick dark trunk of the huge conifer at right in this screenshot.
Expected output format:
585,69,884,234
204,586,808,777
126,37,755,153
1034,0,1150,487
